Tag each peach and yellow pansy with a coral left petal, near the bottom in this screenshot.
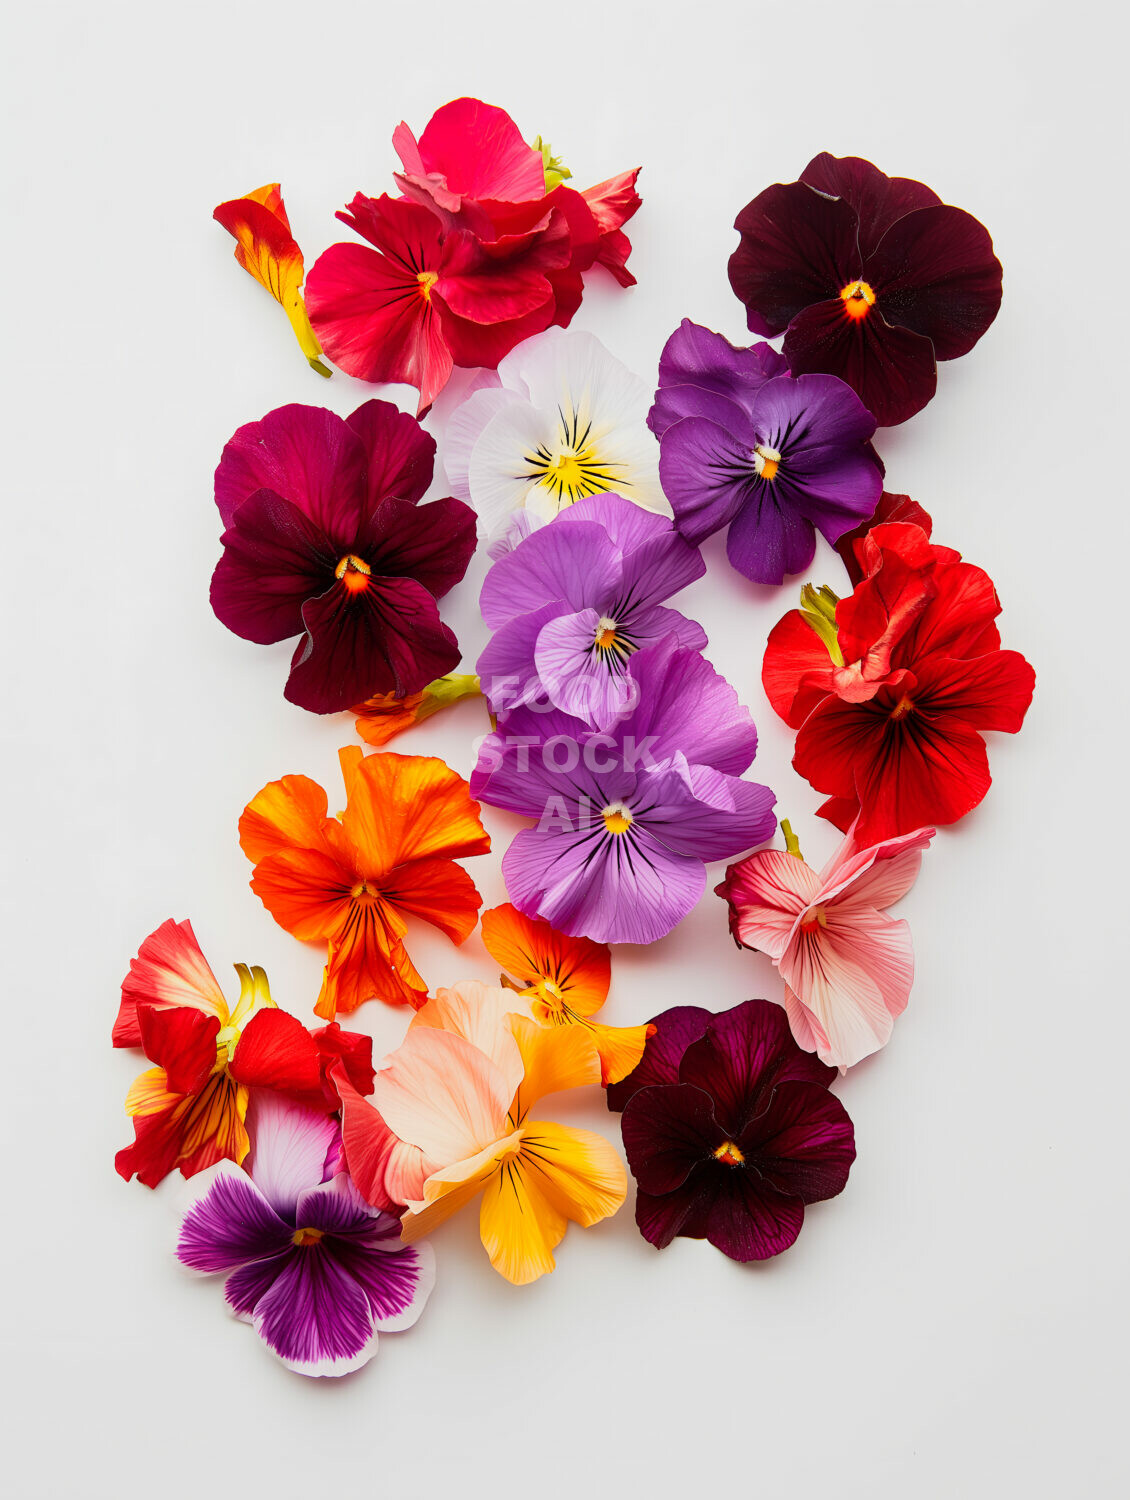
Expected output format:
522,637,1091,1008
341,984,627,1286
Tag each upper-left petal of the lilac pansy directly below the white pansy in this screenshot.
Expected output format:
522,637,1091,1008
479,521,620,630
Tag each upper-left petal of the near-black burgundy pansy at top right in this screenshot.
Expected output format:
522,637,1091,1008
729,183,861,336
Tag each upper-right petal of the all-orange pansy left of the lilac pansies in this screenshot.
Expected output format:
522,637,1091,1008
339,746,491,876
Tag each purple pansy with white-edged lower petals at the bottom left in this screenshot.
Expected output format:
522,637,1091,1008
177,1091,435,1376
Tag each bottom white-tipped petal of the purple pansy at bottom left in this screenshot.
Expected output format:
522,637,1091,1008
254,1241,377,1376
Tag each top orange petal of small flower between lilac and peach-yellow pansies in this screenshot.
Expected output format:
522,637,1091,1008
483,902,612,1016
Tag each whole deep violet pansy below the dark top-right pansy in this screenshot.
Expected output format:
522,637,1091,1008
648,320,882,584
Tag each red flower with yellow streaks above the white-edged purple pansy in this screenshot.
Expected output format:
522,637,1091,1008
113,920,372,1188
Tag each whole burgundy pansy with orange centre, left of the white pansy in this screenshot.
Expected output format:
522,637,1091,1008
212,401,474,714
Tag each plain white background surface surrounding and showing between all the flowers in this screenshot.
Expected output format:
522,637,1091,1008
0,0,1130,1500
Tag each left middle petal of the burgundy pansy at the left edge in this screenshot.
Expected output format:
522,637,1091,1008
210,489,338,645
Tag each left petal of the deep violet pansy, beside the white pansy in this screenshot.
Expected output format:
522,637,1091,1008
659,407,756,542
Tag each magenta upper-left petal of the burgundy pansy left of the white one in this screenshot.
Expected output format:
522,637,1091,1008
216,405,366,537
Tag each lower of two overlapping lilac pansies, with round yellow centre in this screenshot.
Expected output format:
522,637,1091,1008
471,639,776,944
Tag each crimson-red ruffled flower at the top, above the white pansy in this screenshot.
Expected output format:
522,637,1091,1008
306,99,639,413
